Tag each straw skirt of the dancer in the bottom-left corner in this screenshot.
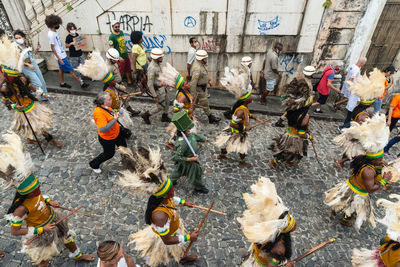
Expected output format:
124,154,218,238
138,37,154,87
21,212,69,265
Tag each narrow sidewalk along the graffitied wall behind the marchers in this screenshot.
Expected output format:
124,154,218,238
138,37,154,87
44,71,345,121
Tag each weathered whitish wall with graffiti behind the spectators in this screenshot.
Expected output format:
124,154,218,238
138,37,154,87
3,0,398,88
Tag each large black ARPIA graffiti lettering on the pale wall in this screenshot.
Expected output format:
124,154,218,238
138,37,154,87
106,12,153,33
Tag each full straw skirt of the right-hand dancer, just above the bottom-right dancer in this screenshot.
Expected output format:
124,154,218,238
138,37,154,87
324,181,376,231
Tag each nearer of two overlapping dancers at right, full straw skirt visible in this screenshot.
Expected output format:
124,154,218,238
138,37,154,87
324,114,389,231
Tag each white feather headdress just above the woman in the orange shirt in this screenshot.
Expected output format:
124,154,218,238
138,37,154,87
78,50,114,83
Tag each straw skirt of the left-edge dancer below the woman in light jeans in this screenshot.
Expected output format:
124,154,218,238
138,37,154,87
12,102,53,139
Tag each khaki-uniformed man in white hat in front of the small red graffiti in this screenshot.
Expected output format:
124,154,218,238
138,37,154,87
190,50,221,123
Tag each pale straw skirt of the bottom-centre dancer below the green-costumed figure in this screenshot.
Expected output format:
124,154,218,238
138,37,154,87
128,220,186,266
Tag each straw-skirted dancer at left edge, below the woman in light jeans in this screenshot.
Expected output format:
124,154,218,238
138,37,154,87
0,37,63,147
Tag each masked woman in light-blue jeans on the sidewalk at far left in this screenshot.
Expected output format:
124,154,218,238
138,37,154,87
14,30,48,101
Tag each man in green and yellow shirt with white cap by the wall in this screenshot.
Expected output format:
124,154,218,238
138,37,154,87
108,20,132,85
